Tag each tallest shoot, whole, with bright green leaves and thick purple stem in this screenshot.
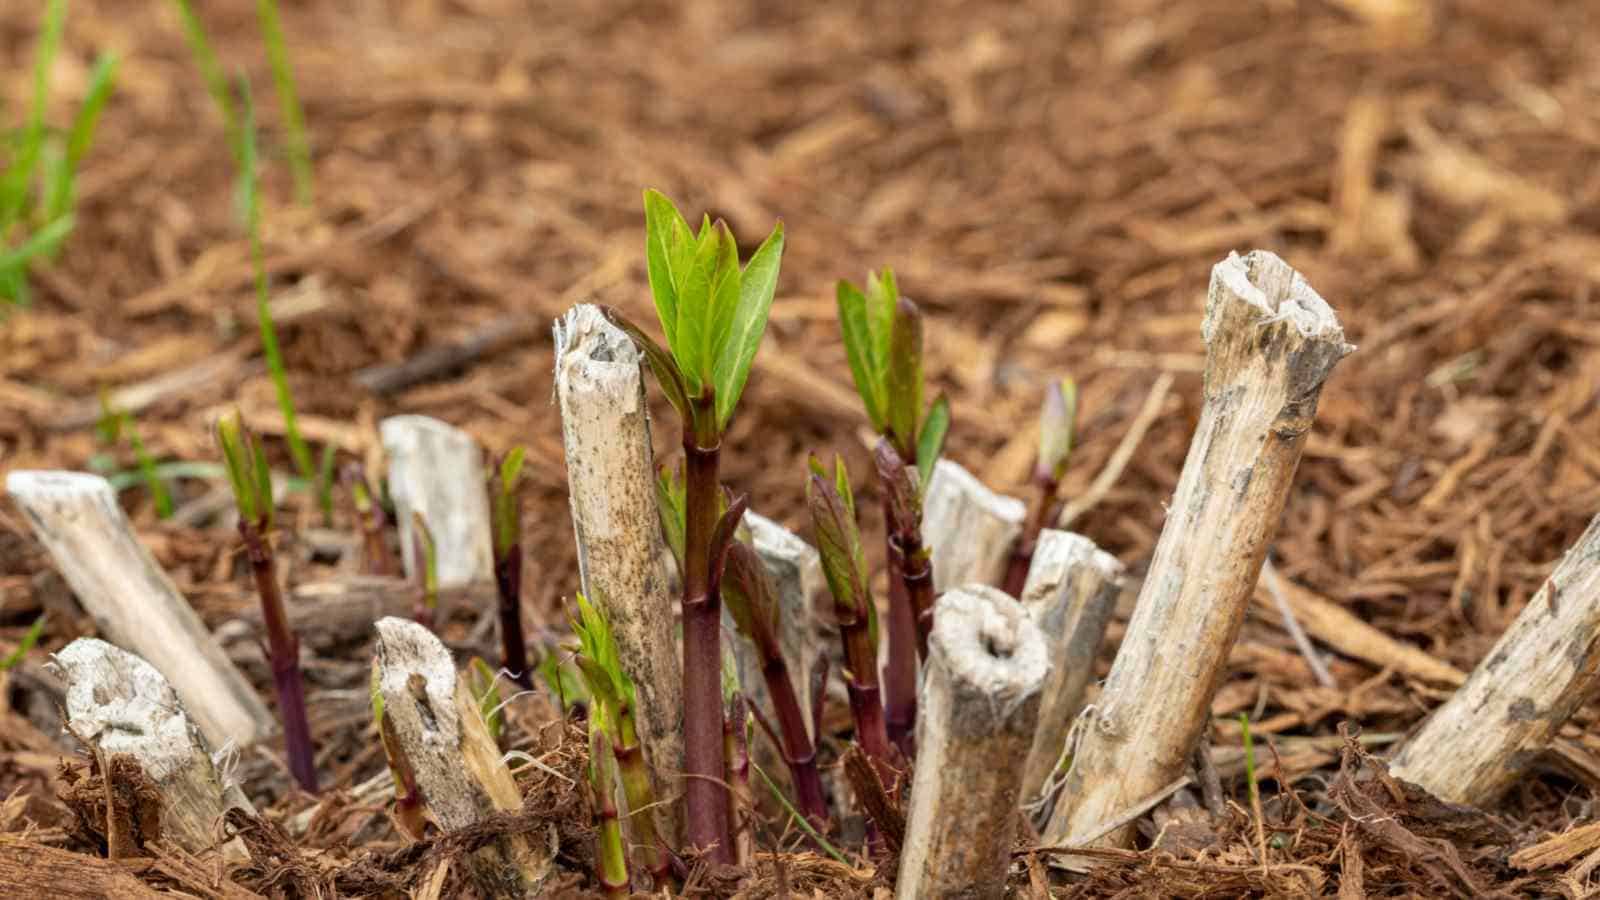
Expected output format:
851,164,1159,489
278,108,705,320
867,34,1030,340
606,191,784,863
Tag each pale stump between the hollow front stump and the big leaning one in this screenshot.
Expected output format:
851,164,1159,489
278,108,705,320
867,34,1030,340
1022,528,1123,810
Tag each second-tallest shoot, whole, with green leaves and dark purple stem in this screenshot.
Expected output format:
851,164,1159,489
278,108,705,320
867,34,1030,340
837,269,950,751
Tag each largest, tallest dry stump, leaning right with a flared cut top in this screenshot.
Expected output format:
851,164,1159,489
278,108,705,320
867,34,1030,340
1045,250,1354,845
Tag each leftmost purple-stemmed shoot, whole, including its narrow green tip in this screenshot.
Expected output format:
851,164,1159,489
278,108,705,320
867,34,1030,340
216,412,317,793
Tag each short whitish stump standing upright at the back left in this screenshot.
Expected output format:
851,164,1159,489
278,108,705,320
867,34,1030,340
378,415,494,588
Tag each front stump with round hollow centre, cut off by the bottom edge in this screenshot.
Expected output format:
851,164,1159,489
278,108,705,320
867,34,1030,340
894,585,1050,900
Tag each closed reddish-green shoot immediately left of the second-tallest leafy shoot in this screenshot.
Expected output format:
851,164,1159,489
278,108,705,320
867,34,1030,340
805,456,896,785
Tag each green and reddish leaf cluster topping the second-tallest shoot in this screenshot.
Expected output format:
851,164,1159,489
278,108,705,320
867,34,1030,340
837,269,950,484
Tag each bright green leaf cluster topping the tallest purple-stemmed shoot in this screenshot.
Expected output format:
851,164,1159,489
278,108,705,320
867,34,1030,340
640,191,784,432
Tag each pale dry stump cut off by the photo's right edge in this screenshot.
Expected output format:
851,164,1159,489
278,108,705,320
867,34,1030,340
1389,516,1600,806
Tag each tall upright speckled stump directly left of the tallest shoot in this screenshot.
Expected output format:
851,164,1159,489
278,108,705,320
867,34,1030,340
555,304,683,834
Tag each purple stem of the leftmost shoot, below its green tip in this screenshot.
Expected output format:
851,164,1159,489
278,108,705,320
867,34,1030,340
238,519,317,794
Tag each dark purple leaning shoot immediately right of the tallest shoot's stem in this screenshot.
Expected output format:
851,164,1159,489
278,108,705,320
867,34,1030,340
718,515,827,830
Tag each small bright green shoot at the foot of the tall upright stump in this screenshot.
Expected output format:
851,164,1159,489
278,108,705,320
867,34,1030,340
571,594,668,889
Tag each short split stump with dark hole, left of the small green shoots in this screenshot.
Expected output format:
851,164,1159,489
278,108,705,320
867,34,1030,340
374,617,552,897
